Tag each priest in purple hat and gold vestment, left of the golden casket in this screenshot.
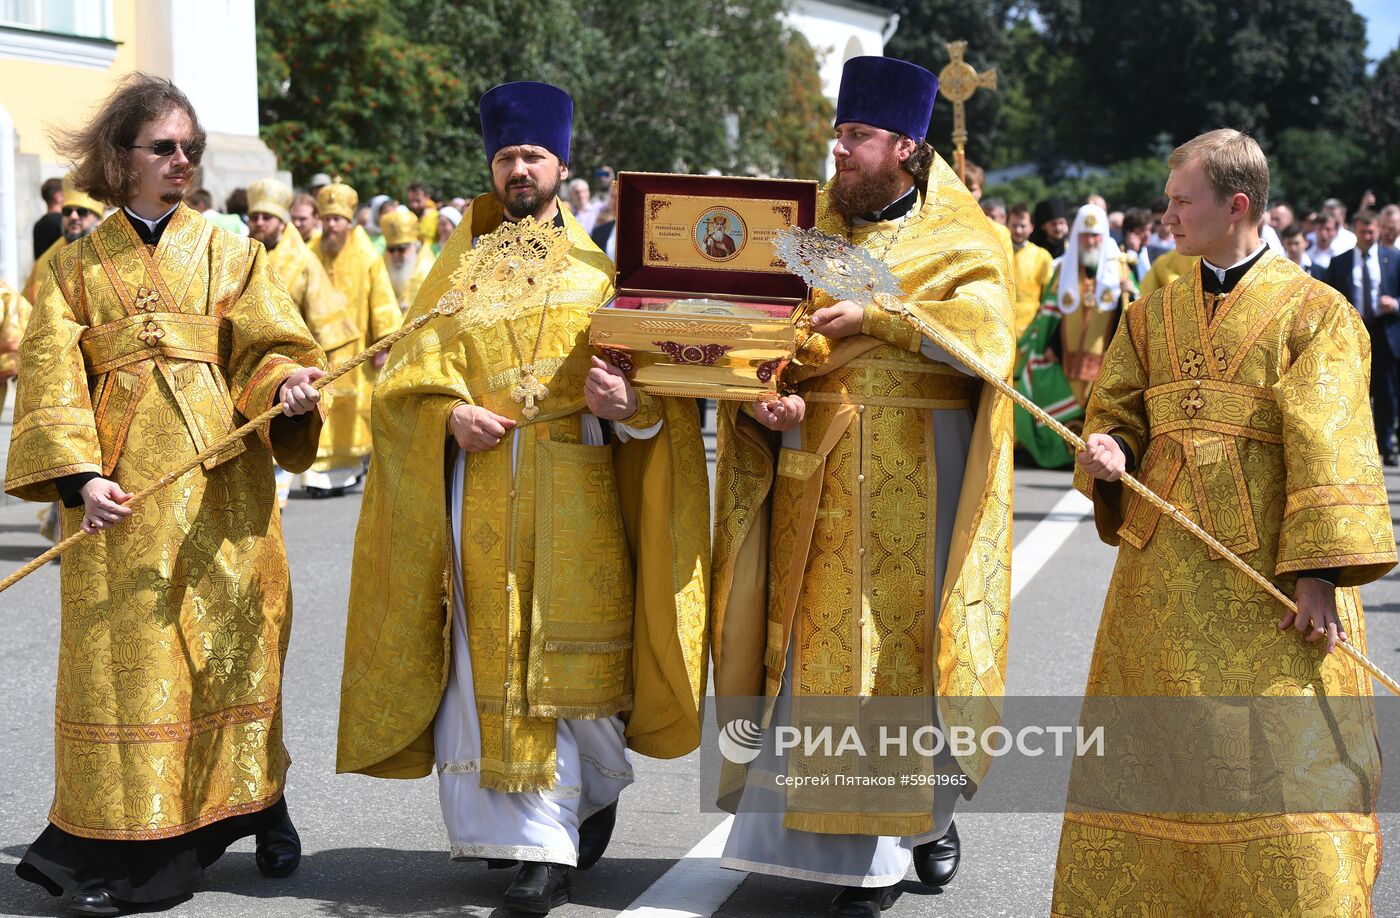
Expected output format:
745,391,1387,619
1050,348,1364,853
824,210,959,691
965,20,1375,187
337,83,710,915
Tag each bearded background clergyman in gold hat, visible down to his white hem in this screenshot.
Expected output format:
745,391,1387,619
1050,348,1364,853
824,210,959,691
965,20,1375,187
302,182,403,497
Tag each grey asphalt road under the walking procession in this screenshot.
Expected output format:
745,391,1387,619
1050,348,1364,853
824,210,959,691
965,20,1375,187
0,411,1400,918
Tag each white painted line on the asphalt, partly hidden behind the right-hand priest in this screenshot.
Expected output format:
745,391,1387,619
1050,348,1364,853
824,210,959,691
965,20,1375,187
617,488,1093,918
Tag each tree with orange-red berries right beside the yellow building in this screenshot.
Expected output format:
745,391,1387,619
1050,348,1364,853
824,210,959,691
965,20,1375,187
258,0,462,190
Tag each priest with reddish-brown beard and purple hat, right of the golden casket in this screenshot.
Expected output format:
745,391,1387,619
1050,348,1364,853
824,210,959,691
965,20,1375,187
711,57,1015,915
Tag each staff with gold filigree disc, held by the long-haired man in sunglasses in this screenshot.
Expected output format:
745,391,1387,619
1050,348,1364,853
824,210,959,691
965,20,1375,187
0,217,573,593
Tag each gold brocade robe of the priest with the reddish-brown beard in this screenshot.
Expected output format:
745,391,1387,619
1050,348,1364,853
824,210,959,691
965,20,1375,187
711,152,1015,835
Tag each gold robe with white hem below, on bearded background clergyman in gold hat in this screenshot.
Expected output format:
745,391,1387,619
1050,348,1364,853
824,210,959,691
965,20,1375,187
311,227,403,472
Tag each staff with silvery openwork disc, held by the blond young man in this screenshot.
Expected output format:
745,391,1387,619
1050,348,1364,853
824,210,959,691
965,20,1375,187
774,228,1400,695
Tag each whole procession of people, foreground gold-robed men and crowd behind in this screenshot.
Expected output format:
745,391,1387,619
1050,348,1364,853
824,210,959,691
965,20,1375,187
0,56,1400,918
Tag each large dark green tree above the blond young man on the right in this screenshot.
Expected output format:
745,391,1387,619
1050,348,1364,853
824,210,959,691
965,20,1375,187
1037,0,1366,162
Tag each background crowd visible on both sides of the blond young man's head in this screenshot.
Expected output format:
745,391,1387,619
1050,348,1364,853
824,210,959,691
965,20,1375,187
966,164,1400,467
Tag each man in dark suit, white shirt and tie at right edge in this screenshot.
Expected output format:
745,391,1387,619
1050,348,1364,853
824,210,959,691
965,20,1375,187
1327,210,1400,466
